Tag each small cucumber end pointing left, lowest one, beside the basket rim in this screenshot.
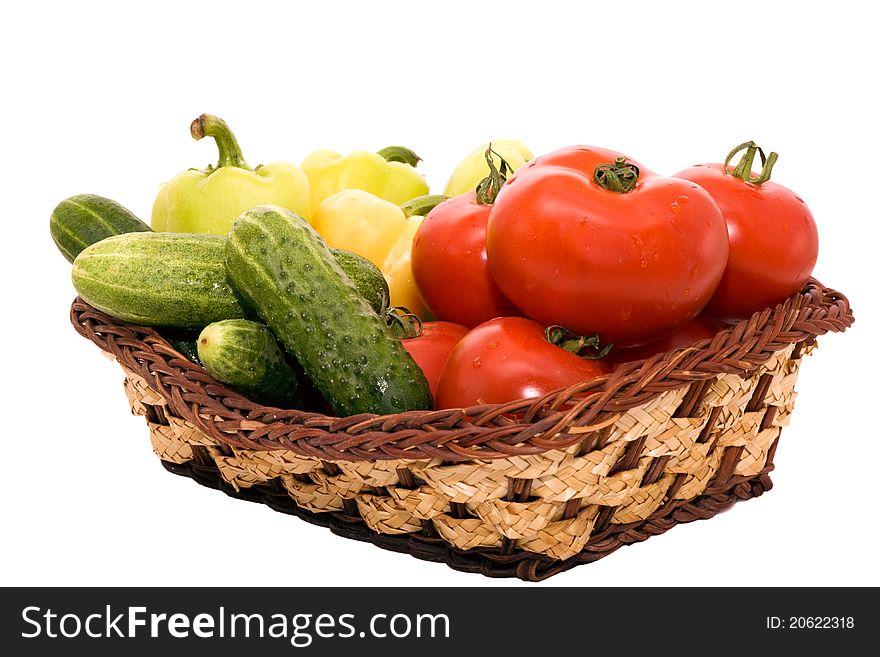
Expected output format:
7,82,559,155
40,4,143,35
196,319,303,407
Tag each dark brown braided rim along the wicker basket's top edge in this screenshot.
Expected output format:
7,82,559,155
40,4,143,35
70,279,854,462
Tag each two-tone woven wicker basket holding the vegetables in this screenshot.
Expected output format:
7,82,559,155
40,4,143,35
71,281,853,580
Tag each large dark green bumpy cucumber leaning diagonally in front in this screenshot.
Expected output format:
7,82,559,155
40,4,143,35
226,206,433,416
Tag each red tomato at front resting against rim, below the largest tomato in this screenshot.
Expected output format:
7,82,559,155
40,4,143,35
435,317,609,409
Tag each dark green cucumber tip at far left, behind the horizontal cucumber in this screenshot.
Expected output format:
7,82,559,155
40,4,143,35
49,194,150,262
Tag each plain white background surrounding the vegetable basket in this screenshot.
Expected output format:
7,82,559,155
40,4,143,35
0,0,880,586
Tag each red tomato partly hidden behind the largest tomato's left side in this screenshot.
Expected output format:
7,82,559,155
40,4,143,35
412,192,520,328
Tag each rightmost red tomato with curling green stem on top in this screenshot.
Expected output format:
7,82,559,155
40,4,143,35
675,142,819,319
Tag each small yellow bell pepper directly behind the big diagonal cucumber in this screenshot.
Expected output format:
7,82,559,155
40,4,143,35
313,189,445,318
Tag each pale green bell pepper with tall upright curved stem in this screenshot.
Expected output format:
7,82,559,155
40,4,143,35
151,114,311,235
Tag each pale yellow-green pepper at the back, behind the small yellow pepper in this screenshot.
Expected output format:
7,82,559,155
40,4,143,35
302,146,428,210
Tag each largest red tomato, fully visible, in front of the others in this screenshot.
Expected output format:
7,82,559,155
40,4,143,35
486,146,728,347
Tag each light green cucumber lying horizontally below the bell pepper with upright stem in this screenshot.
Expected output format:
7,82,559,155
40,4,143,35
71,233,252,329
